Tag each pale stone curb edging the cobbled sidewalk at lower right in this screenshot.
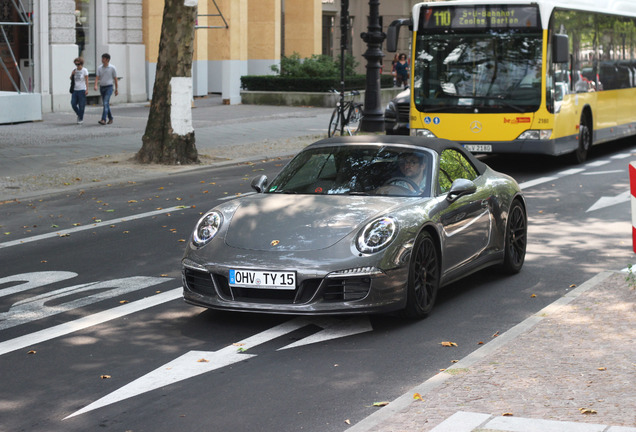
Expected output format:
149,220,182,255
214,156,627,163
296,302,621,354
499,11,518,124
346,271,620,432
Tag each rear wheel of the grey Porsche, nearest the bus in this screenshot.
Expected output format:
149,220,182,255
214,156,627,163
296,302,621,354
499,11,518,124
501,200,528,274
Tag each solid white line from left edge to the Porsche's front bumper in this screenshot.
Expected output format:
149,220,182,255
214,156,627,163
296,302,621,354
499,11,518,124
0,288,183,355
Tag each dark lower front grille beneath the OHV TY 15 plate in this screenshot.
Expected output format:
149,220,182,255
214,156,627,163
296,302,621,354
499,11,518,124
184,268,371,304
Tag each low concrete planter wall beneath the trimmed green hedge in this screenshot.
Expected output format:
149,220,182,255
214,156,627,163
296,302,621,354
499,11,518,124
241,88,402,108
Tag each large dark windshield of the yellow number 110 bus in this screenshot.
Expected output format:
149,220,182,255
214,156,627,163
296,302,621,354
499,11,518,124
413,28,542,113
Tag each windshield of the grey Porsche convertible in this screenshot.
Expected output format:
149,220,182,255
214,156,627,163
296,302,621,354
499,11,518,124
268,144,433,196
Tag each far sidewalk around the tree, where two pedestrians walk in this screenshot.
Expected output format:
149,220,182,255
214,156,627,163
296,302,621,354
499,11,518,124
0,95,332,202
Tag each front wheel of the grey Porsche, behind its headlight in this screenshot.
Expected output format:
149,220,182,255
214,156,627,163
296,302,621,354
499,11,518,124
404,231,440,319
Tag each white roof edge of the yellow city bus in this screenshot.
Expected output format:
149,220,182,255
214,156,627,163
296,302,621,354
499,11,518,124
413,0,636,31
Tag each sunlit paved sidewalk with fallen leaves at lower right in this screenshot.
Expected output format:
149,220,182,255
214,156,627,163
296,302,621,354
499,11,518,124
347,272,636,432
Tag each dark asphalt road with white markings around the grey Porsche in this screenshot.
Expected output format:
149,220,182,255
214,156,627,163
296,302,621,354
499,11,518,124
0,140,634,432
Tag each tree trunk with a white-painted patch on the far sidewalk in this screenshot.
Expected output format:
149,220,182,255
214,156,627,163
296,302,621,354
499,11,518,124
135,0,199,165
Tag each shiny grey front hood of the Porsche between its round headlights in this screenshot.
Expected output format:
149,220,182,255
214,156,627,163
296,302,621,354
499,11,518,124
225,194,404,252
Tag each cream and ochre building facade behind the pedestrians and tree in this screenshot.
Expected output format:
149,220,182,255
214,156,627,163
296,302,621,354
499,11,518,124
0,0,416,123
